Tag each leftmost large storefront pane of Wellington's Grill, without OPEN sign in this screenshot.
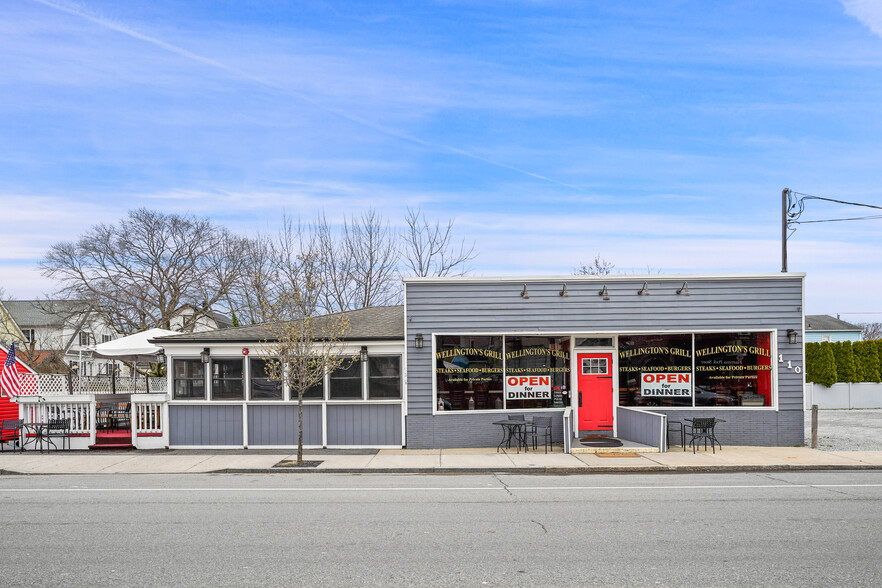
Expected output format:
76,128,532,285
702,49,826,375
435,335,504,410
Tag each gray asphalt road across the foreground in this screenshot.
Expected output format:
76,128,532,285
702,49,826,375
0,471,882,587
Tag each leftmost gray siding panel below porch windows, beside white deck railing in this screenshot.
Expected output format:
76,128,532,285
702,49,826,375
168,404,244,447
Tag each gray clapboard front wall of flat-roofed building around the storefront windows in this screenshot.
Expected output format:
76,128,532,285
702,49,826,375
405,274,804,448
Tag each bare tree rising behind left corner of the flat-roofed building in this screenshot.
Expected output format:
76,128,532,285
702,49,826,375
401,207,478,277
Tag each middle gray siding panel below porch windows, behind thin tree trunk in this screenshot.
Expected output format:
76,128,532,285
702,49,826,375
248,404,322,446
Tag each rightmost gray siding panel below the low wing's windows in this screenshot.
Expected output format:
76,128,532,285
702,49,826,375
328,404,401,446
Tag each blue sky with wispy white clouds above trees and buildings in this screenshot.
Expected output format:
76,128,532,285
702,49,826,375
0,0,882,320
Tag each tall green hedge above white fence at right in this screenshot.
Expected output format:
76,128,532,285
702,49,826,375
805,340,882,386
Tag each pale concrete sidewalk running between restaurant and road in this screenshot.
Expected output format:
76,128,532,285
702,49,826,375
0,447,882,475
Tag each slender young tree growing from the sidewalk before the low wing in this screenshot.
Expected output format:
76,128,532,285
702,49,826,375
262,252,354,464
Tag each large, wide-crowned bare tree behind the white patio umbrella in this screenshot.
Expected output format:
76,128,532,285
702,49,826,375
40,208,245,333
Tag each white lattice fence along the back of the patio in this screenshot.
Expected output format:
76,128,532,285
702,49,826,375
20,374,168,396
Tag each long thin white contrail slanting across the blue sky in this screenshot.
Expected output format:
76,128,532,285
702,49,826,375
31,0,582,192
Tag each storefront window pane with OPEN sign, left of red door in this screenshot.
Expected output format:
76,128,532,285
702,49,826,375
505,336,570,409
